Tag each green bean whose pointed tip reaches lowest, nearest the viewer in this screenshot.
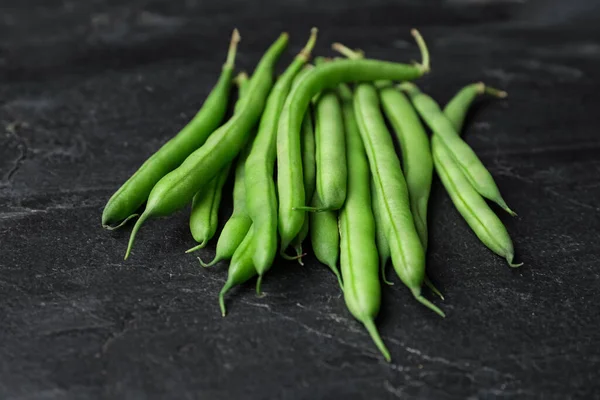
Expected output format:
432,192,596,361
339,94,391,362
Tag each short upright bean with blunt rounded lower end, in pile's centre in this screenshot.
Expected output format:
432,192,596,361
314,90,348,210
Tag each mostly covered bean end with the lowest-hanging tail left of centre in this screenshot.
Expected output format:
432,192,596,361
219,225,256,316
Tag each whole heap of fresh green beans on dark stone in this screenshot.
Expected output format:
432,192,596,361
102,28,522,361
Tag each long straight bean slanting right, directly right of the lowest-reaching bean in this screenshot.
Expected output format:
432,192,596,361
354,84,444,316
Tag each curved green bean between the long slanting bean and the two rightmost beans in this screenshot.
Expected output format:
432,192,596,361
380,87,433,249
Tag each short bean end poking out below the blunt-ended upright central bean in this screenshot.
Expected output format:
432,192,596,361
310,192,344,290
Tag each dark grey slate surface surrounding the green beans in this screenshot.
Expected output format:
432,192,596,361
0,0,600,399
